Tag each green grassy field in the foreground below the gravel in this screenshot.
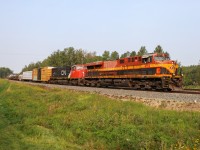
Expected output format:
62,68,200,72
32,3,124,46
0,80,200,150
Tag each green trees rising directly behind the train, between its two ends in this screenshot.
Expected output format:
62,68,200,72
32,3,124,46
22,45,169,72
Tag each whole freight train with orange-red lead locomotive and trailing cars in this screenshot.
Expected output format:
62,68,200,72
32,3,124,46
8,53,182,91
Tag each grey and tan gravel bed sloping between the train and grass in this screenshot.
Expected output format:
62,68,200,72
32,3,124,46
11,81,200,112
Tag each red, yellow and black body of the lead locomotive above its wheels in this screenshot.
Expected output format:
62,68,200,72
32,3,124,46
85,53,182,88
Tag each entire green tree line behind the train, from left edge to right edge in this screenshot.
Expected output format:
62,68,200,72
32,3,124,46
0,45,200,86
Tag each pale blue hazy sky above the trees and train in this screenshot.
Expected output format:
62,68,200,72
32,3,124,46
0,0,200,73
